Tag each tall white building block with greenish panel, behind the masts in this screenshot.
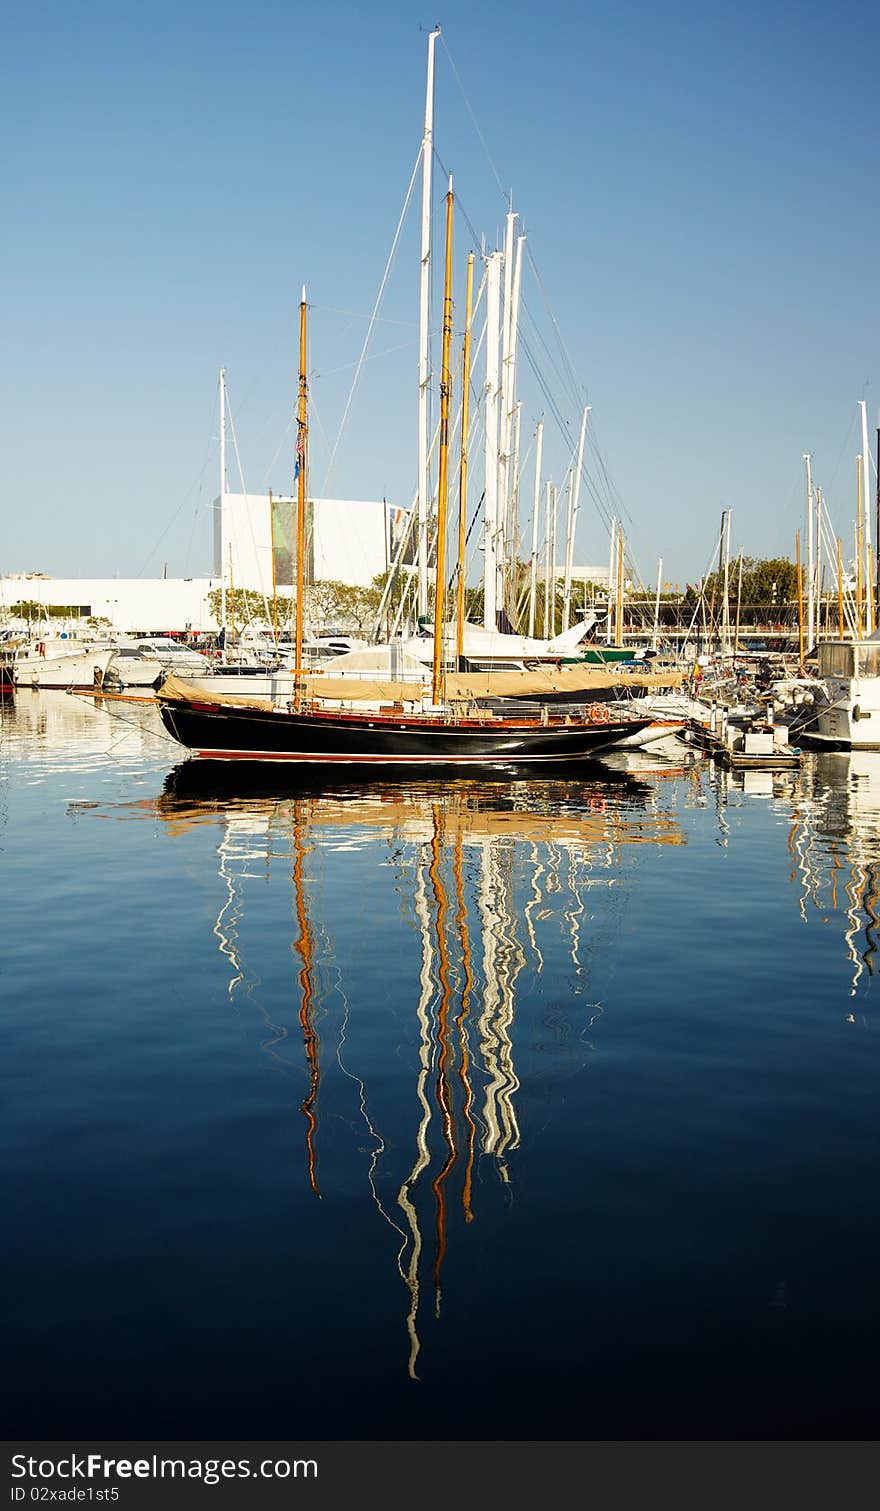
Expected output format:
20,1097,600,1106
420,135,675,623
213,493,408,592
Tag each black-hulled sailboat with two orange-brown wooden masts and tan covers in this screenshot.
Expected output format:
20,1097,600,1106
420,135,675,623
157,196,650,766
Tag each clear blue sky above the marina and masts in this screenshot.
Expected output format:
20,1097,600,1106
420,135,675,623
0,0,880,586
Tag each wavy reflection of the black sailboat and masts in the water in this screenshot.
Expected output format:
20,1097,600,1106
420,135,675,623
148,763,683,1378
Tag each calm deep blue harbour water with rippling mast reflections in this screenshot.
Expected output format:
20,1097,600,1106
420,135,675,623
0,694,880,1440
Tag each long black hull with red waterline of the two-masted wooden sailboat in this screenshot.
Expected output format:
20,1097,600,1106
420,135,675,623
159,700,650,766
